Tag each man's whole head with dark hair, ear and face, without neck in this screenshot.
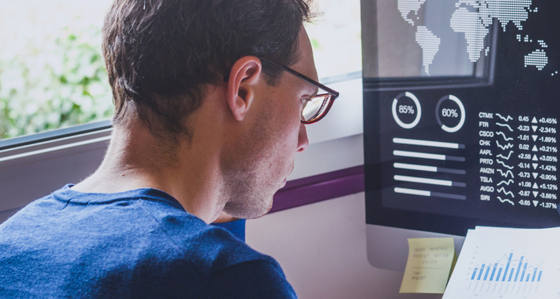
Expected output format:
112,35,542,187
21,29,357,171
103,0,317,218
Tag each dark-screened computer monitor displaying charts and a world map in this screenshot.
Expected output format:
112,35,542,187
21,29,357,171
361,0,560,270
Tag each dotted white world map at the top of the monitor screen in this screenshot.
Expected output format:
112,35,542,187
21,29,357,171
398,0,558,76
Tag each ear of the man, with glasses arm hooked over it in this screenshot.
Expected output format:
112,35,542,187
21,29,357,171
226,56,262,121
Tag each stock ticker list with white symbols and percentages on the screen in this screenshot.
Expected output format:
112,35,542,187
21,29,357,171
478,112,558,209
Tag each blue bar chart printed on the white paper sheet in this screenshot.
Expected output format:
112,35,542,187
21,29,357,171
466,252,546,298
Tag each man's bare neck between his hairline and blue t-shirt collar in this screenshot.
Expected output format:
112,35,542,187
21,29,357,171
72,125,225,223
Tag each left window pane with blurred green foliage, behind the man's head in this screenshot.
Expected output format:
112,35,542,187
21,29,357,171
0,0,113,140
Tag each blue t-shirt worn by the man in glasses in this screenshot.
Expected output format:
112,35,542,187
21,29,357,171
0,185,296,298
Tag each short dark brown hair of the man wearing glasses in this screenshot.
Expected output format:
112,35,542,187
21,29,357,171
103,0,311,141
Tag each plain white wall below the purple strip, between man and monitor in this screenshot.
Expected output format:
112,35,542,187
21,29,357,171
246,193,442,299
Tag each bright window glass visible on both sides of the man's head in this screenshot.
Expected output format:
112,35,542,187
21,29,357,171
0,0,361,140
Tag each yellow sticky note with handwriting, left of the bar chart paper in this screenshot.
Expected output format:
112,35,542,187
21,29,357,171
400,238,455,294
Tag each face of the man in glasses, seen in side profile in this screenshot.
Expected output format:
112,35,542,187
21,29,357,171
224,27,317,219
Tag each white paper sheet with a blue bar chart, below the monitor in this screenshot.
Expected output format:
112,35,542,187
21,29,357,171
443,227,560,299
